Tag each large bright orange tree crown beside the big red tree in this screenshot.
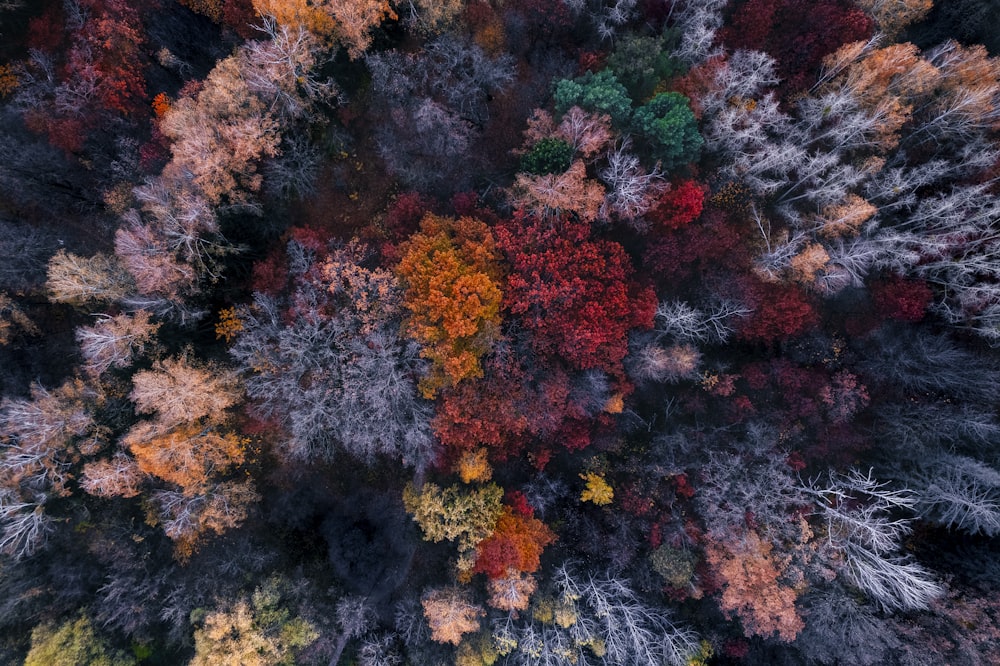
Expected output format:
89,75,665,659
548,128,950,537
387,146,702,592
396,214,502,398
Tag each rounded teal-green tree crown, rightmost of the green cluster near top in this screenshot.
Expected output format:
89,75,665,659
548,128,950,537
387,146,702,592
632,92,704,169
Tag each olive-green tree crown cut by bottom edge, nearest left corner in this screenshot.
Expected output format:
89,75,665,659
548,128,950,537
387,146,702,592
24,615,136,666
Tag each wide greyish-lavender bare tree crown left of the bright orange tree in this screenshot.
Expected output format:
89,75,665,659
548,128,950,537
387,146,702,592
230,298,434,468
